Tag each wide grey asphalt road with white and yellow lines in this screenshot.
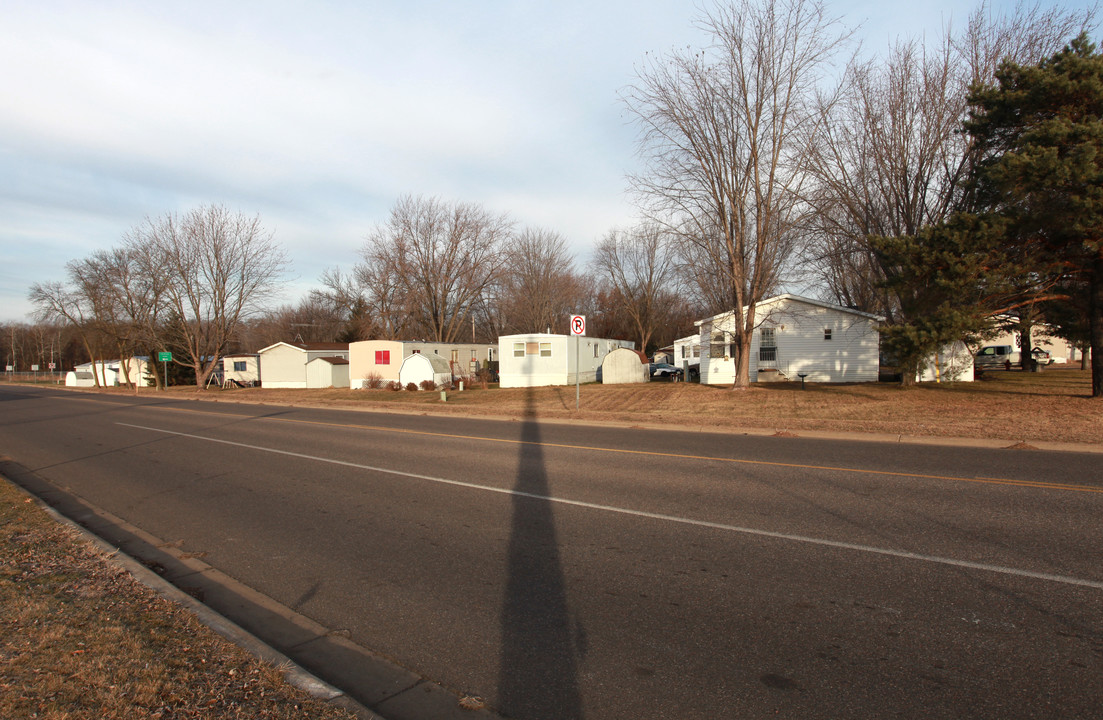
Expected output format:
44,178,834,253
0,386,1103,720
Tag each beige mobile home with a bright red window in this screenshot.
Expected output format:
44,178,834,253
349,340,497,388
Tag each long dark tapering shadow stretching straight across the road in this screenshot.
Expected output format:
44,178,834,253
499,390,582,720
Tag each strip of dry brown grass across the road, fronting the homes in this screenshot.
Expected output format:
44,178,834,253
88,367,1103,443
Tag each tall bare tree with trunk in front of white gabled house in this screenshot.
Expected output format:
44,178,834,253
625,0,844,387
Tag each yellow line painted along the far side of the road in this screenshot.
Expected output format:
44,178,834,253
135,407,1103,493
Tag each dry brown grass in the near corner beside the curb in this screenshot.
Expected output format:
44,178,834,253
0,481,353,720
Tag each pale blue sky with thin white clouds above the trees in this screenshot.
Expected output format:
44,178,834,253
0,0,1083,321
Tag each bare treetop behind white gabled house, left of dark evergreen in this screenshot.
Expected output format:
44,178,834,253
806,3,1095,323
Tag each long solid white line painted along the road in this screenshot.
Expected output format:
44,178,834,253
116,422,1103,590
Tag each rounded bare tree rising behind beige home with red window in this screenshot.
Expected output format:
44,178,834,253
355,196,513,343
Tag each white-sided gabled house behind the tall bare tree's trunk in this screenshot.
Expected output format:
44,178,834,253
697,294,880,385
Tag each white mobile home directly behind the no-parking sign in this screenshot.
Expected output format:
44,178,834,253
497,333,635,387
